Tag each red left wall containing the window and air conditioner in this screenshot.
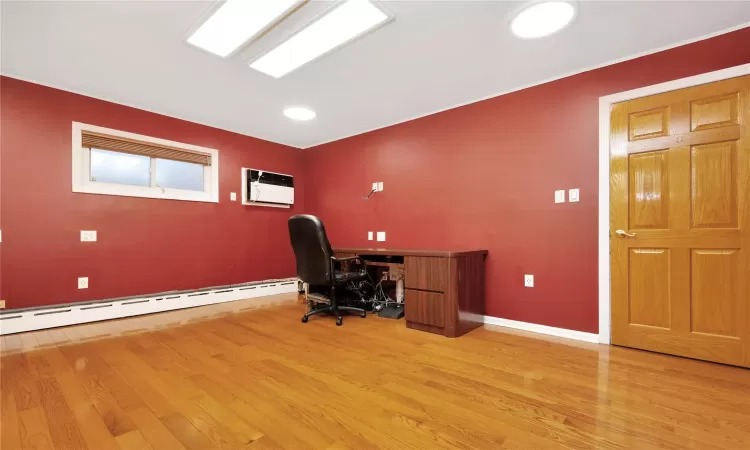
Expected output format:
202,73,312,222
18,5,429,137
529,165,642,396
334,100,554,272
0,77,304,308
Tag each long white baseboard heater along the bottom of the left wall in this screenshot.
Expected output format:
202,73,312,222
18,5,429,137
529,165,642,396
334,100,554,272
0,278,297,335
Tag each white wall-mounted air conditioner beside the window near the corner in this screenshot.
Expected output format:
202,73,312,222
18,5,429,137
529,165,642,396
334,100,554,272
242,167,294,208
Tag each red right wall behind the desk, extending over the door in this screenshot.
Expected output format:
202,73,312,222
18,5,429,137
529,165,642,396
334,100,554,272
305,28,750,332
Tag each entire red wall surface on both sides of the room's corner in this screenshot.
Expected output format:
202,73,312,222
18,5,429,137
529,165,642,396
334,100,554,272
0,28,750,324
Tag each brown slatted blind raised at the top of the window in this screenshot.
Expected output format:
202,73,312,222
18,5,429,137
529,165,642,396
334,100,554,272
81,130,211,166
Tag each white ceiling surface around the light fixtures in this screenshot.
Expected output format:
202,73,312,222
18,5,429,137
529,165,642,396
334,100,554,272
0,0,750,148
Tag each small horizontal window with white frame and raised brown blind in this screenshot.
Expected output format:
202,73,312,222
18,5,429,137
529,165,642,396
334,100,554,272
73,122,219,202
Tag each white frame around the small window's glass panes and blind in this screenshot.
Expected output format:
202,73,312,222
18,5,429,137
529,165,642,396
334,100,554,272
73,122,219,203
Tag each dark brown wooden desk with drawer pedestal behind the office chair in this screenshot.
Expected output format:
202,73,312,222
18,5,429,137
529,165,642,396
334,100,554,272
333,248,487,337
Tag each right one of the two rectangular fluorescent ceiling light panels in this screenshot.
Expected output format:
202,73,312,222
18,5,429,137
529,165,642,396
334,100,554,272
250,0,390,78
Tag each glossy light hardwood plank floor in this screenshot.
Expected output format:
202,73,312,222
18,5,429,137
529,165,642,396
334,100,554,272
0,296,750,450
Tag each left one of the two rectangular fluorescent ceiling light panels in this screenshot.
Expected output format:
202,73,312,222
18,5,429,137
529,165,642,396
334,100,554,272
188,0,305,57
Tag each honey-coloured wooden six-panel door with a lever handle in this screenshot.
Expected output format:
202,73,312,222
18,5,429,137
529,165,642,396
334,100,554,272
610,76,750,367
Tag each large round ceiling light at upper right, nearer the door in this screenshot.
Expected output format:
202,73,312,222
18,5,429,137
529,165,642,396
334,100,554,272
510,0,576,39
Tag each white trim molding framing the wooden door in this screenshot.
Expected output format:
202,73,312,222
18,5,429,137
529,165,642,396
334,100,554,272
599,64,750,344
